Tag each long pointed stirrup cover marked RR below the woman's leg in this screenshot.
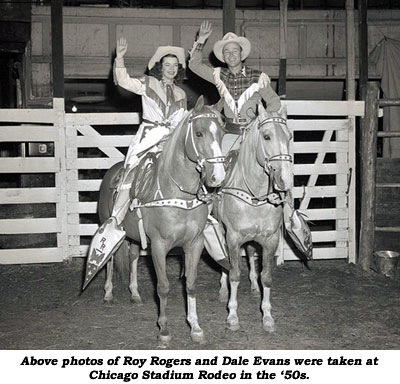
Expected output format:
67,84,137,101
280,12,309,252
82,217,126,290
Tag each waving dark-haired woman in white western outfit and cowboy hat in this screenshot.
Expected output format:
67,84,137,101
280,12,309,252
88,37,187,268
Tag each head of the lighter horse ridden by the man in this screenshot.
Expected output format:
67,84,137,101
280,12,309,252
256,104,293,191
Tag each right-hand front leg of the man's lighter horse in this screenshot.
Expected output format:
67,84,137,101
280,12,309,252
261,231,279,332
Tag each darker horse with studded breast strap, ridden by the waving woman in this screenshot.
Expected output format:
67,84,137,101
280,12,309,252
99,97,225,342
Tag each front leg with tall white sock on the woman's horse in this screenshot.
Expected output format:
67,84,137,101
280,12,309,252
183,237,204,343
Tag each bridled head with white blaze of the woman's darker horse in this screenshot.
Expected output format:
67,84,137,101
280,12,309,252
185,96,225,187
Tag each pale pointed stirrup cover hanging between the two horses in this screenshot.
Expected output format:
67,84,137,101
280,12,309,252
203,215,231,271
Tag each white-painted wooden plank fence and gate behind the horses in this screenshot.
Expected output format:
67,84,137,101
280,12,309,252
0,99,364,264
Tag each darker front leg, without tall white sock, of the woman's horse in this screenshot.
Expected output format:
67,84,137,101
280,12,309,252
151,239,171,343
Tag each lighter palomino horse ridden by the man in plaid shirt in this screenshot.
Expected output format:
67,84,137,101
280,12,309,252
217,105,293,332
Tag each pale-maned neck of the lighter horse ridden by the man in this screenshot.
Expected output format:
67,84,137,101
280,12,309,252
227,122,269,194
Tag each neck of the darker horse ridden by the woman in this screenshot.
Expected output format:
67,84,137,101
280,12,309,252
157,114,200,198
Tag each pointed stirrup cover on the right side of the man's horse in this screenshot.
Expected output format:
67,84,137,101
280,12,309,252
283,202,313,260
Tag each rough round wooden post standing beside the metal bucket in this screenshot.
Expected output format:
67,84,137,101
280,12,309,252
358,82,379,270
